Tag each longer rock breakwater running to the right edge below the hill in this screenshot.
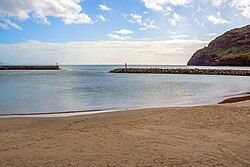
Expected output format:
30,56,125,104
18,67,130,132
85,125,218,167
110,68,250,76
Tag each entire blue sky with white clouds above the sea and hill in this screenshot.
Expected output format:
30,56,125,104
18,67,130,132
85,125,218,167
0,0,250,64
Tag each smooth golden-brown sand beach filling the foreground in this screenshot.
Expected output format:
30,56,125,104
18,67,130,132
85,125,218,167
0,101,250,167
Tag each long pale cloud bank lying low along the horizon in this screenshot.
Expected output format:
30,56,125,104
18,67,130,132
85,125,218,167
0,39,208,64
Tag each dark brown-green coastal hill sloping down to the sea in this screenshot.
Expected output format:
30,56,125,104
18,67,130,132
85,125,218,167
188,25,250,66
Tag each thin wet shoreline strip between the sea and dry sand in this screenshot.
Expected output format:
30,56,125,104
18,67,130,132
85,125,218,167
0,92,250,119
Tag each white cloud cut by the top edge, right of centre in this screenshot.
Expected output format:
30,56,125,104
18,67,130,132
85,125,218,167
142,0,190,14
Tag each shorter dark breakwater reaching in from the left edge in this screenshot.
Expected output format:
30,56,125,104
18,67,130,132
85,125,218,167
0,65,60,70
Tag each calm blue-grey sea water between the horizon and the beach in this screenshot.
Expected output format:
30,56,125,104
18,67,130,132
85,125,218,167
0,65,250,114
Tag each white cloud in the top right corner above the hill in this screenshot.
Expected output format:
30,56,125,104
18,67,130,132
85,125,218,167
230,0,250,18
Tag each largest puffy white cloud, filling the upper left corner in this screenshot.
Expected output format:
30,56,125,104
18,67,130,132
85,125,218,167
0,0,92,29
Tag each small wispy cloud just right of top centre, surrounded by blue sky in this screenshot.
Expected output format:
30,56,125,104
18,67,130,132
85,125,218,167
129,13,157,30
